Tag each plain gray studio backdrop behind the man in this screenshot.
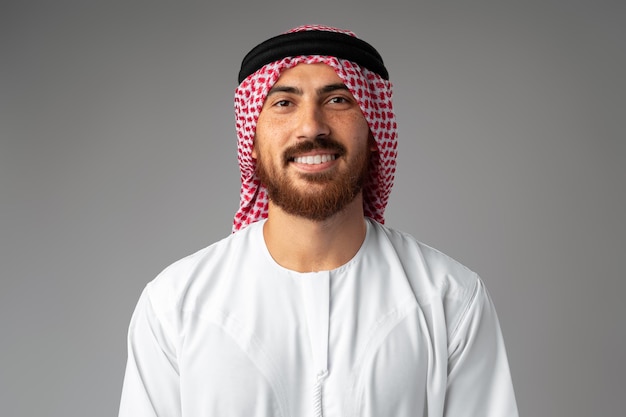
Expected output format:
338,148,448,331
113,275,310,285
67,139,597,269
0,0,626,417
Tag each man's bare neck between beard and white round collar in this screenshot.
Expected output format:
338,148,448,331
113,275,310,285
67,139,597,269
263,195,366,272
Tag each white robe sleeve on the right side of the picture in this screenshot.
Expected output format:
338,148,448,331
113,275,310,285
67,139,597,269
444,279,518,417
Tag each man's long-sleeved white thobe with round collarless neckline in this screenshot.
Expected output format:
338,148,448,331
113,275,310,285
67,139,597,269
119,220,517,417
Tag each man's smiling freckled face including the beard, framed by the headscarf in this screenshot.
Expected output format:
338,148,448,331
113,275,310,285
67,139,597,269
252,64,375,221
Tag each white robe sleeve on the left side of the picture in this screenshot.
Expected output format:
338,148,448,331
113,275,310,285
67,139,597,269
119,288,181,417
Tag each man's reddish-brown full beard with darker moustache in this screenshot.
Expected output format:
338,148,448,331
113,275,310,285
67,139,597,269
256,138,373,221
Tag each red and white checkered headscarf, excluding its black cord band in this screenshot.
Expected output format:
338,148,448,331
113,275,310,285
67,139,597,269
233,25,398,232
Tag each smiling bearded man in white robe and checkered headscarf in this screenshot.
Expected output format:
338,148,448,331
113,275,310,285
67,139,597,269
120,26,517,417
